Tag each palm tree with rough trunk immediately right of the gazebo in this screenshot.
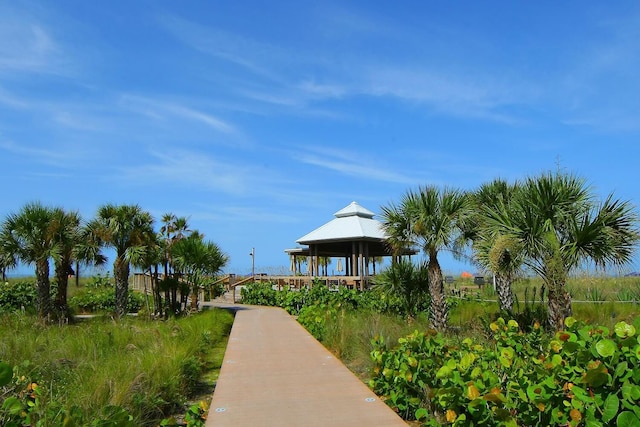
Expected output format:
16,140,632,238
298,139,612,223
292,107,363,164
382,186,470,331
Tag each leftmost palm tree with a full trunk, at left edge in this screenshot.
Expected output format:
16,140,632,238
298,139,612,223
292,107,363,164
0,202,57,319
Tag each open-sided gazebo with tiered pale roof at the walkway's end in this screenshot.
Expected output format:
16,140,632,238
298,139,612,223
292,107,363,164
285,202,416,289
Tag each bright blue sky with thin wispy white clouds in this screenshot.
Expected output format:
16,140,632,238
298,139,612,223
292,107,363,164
0,0,640,274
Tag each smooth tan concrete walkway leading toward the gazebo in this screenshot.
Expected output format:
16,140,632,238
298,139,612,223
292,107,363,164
206,305,407,427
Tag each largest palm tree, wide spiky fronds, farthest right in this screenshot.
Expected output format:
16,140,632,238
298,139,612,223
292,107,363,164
487,172,640,330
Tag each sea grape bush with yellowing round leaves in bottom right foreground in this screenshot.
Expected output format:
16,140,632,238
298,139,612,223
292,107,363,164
370,318,640,427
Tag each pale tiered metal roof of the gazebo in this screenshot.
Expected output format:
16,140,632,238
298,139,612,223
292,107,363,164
296,202,387,245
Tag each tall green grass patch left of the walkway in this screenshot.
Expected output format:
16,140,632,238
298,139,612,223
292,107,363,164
0,310,233,426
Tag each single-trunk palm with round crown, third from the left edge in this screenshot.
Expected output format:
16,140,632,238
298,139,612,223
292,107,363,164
89,204,153,317
